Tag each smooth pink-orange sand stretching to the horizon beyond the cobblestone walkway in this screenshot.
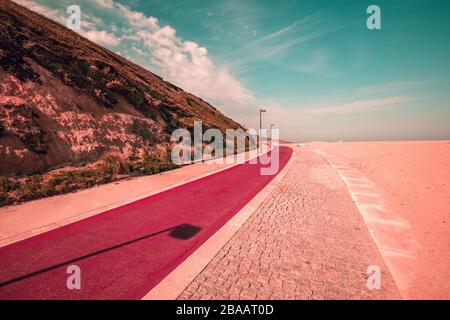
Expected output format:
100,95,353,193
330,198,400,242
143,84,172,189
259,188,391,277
308,141,450,299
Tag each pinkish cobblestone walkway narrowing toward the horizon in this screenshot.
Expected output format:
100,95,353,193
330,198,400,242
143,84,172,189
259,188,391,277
179,146,400,299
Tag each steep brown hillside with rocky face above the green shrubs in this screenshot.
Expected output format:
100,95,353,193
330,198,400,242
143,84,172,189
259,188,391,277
0,0,241,205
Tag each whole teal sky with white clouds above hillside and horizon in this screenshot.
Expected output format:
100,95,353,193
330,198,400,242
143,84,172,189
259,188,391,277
16,0,450,141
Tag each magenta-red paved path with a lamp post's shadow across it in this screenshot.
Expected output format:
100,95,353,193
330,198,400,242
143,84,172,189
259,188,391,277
0,147,292,299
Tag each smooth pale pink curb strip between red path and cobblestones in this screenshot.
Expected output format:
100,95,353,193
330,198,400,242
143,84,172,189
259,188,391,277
142,146,295,300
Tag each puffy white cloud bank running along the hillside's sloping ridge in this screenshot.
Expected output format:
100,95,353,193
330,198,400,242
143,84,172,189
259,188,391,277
16,0,256,117
